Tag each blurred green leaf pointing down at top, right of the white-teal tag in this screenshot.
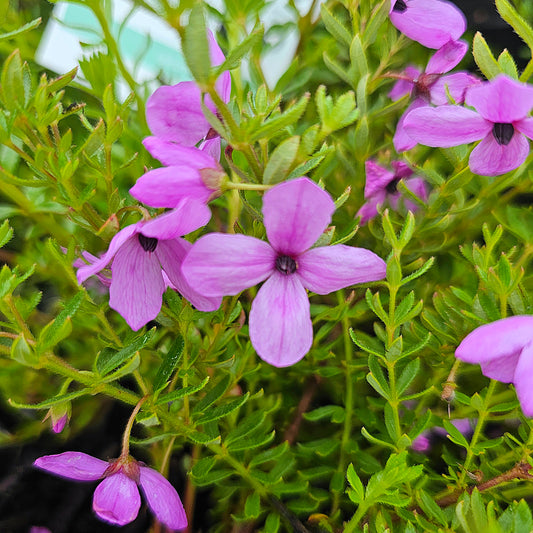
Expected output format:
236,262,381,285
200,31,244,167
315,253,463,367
183,2,211,84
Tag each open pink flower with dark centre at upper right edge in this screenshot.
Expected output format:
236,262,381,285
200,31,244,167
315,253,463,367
404,74,533,176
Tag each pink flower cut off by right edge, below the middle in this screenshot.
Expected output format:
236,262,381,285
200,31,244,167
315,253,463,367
455,315,533,417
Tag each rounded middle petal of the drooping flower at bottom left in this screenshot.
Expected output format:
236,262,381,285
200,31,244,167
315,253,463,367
93,472,141,526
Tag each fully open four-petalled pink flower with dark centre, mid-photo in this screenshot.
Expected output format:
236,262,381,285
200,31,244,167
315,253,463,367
182,177,386,367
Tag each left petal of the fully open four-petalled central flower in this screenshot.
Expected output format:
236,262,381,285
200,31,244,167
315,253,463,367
182,233,276,296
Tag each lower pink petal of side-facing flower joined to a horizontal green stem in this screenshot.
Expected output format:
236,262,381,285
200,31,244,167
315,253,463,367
130,166,213,207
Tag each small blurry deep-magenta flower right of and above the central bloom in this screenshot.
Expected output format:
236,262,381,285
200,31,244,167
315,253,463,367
357,161,428,224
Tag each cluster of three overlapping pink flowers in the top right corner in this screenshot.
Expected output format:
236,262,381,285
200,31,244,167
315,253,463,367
389,0,533,176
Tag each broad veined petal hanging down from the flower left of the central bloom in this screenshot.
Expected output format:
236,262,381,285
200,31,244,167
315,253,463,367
109,237,165,331
